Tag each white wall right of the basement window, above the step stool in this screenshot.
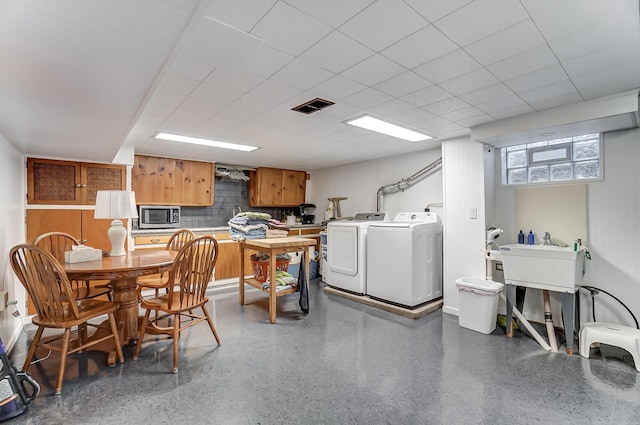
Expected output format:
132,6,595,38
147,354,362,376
581,129,640,327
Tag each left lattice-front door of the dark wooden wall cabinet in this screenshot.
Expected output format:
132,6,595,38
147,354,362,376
27,158,82,205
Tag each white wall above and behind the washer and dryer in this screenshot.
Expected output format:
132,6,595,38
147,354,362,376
307,149,442,219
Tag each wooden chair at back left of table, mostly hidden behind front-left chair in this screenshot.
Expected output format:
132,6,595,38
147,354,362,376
33,232,111,301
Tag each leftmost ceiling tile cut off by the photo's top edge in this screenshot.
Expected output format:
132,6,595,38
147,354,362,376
207,0,277,32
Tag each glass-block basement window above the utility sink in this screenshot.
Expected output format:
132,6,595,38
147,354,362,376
500,133,602,185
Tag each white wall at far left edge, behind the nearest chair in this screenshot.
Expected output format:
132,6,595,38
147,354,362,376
0,135,26,350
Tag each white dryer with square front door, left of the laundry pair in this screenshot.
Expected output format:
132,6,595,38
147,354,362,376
325,213,386,294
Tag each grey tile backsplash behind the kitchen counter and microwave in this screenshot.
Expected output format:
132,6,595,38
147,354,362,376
133,177,291,229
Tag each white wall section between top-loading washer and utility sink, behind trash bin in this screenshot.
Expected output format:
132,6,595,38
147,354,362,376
442,137,486,315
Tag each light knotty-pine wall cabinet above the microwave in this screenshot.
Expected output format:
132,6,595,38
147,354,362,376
131,155,213,206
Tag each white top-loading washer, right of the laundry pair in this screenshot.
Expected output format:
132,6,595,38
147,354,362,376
367,212,442,307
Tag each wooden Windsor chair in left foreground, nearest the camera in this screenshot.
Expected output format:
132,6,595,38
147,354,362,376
9,244,124,394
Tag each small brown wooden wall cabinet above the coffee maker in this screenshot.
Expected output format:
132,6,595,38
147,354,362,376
249,167,307,207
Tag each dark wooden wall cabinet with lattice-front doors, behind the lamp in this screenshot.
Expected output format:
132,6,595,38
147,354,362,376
27,158,126,205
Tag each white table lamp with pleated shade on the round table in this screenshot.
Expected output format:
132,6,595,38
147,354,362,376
93,190,138,257
